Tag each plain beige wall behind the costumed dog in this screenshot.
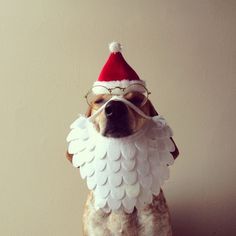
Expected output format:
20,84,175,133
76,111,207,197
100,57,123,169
0,0,236,236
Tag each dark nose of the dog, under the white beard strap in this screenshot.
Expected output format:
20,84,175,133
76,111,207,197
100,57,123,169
105,101,128,119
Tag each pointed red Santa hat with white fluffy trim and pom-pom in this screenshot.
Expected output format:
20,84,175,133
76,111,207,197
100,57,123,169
92,42,145,94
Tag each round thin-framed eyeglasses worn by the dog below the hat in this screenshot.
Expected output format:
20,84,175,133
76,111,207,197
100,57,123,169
85,84,151,109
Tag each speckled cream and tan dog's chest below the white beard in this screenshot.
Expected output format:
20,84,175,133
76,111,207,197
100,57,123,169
84,192,172,236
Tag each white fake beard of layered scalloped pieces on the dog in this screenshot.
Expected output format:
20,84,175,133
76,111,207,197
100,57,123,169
67,98,175,213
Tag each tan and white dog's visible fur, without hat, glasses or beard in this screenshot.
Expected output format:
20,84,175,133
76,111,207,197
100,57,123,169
66,92,179,236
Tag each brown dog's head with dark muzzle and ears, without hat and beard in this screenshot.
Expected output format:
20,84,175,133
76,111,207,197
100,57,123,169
68,91,179,160
